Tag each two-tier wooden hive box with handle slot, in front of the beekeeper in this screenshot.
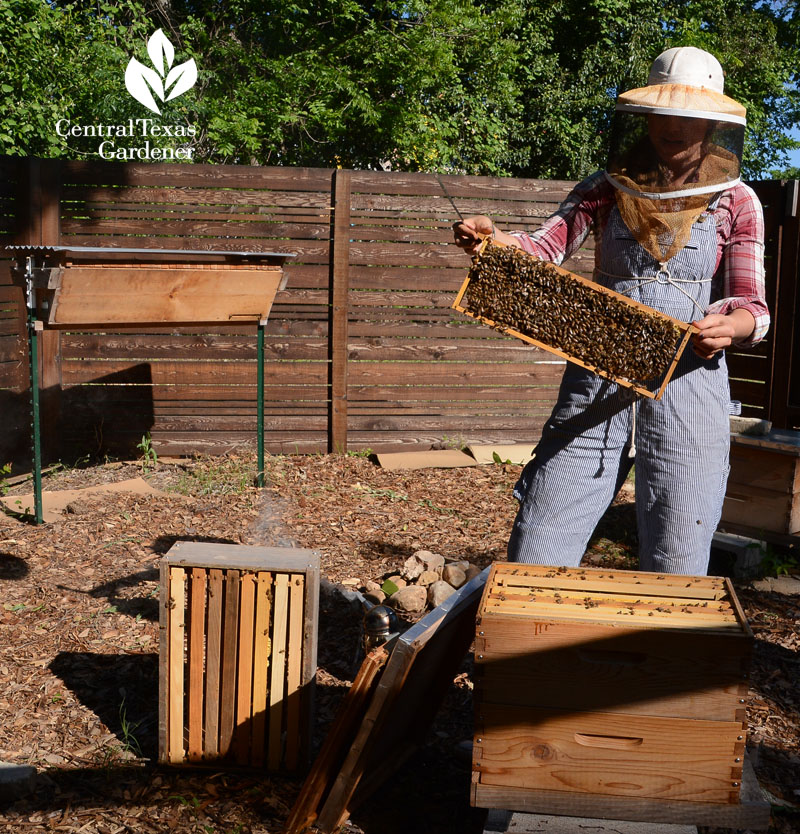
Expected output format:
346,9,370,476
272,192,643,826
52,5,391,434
472,563,764,824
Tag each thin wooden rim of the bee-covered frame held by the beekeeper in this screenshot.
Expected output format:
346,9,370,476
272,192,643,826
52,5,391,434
452,238,700,400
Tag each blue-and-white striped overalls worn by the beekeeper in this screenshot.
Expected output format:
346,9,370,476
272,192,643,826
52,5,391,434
508,197,730,575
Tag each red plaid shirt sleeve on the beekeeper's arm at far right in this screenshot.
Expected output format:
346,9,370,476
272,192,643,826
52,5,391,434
706,184,770,347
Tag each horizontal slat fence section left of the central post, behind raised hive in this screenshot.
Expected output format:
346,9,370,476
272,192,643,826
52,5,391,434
54,159,332,455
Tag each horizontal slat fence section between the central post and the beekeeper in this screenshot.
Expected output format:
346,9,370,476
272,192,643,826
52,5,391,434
340,171,585,448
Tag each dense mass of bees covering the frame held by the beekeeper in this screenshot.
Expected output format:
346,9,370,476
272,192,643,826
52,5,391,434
461,244,681,383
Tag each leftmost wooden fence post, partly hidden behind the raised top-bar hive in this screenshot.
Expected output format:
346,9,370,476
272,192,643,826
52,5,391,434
17,157,62,459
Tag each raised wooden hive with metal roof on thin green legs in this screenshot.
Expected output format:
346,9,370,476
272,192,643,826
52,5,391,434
6,246,294,524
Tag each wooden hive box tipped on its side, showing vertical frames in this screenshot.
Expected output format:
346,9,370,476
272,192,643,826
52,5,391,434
159,542,319,771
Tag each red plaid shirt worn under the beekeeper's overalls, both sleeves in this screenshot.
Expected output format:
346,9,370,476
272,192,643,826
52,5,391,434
512,171,769,346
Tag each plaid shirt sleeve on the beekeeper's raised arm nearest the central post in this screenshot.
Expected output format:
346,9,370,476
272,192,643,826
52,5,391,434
511,171,612,265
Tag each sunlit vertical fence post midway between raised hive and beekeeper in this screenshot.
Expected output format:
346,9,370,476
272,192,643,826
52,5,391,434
328,169,350,454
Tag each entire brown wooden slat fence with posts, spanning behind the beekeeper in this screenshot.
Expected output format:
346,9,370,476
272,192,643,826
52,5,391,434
0,158,800,460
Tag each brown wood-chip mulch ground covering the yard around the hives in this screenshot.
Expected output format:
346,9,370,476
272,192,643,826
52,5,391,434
0,455,800,834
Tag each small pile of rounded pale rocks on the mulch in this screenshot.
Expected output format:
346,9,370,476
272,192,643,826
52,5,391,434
363,550,481,614
